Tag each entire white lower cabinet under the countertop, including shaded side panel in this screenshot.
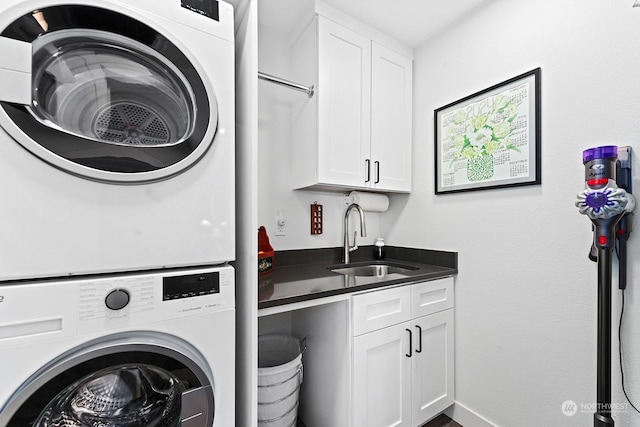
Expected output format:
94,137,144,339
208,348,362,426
270,277,454,427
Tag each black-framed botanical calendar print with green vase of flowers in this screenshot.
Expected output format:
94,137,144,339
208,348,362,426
434,68,541,194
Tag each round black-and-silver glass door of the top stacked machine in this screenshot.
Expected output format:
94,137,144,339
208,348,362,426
0,5,217,183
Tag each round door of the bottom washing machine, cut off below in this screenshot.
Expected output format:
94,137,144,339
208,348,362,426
0,332,215,427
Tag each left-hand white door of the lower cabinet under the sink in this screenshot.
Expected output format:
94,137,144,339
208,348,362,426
353,322,415,427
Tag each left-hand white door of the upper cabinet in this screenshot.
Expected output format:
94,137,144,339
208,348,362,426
317,16,371,188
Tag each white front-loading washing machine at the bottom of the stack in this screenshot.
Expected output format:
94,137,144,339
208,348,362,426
0,266,235,427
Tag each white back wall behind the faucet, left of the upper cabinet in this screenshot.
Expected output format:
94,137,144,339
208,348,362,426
256,19,380,251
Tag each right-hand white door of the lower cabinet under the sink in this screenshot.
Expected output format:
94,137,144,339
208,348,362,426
411,309,454,426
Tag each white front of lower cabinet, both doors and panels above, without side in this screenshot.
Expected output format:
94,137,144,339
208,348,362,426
352,278,454,427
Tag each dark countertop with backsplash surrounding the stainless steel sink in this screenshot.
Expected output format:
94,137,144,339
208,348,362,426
258,246,458,309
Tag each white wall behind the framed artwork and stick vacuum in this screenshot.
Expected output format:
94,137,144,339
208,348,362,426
381,0,640,427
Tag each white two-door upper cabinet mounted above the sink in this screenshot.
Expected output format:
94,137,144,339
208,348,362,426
292,15,413,192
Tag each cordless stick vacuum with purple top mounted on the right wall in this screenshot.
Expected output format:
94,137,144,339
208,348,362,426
576,146,635,427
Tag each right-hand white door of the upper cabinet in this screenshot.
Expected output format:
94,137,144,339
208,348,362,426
371,42,413,192
